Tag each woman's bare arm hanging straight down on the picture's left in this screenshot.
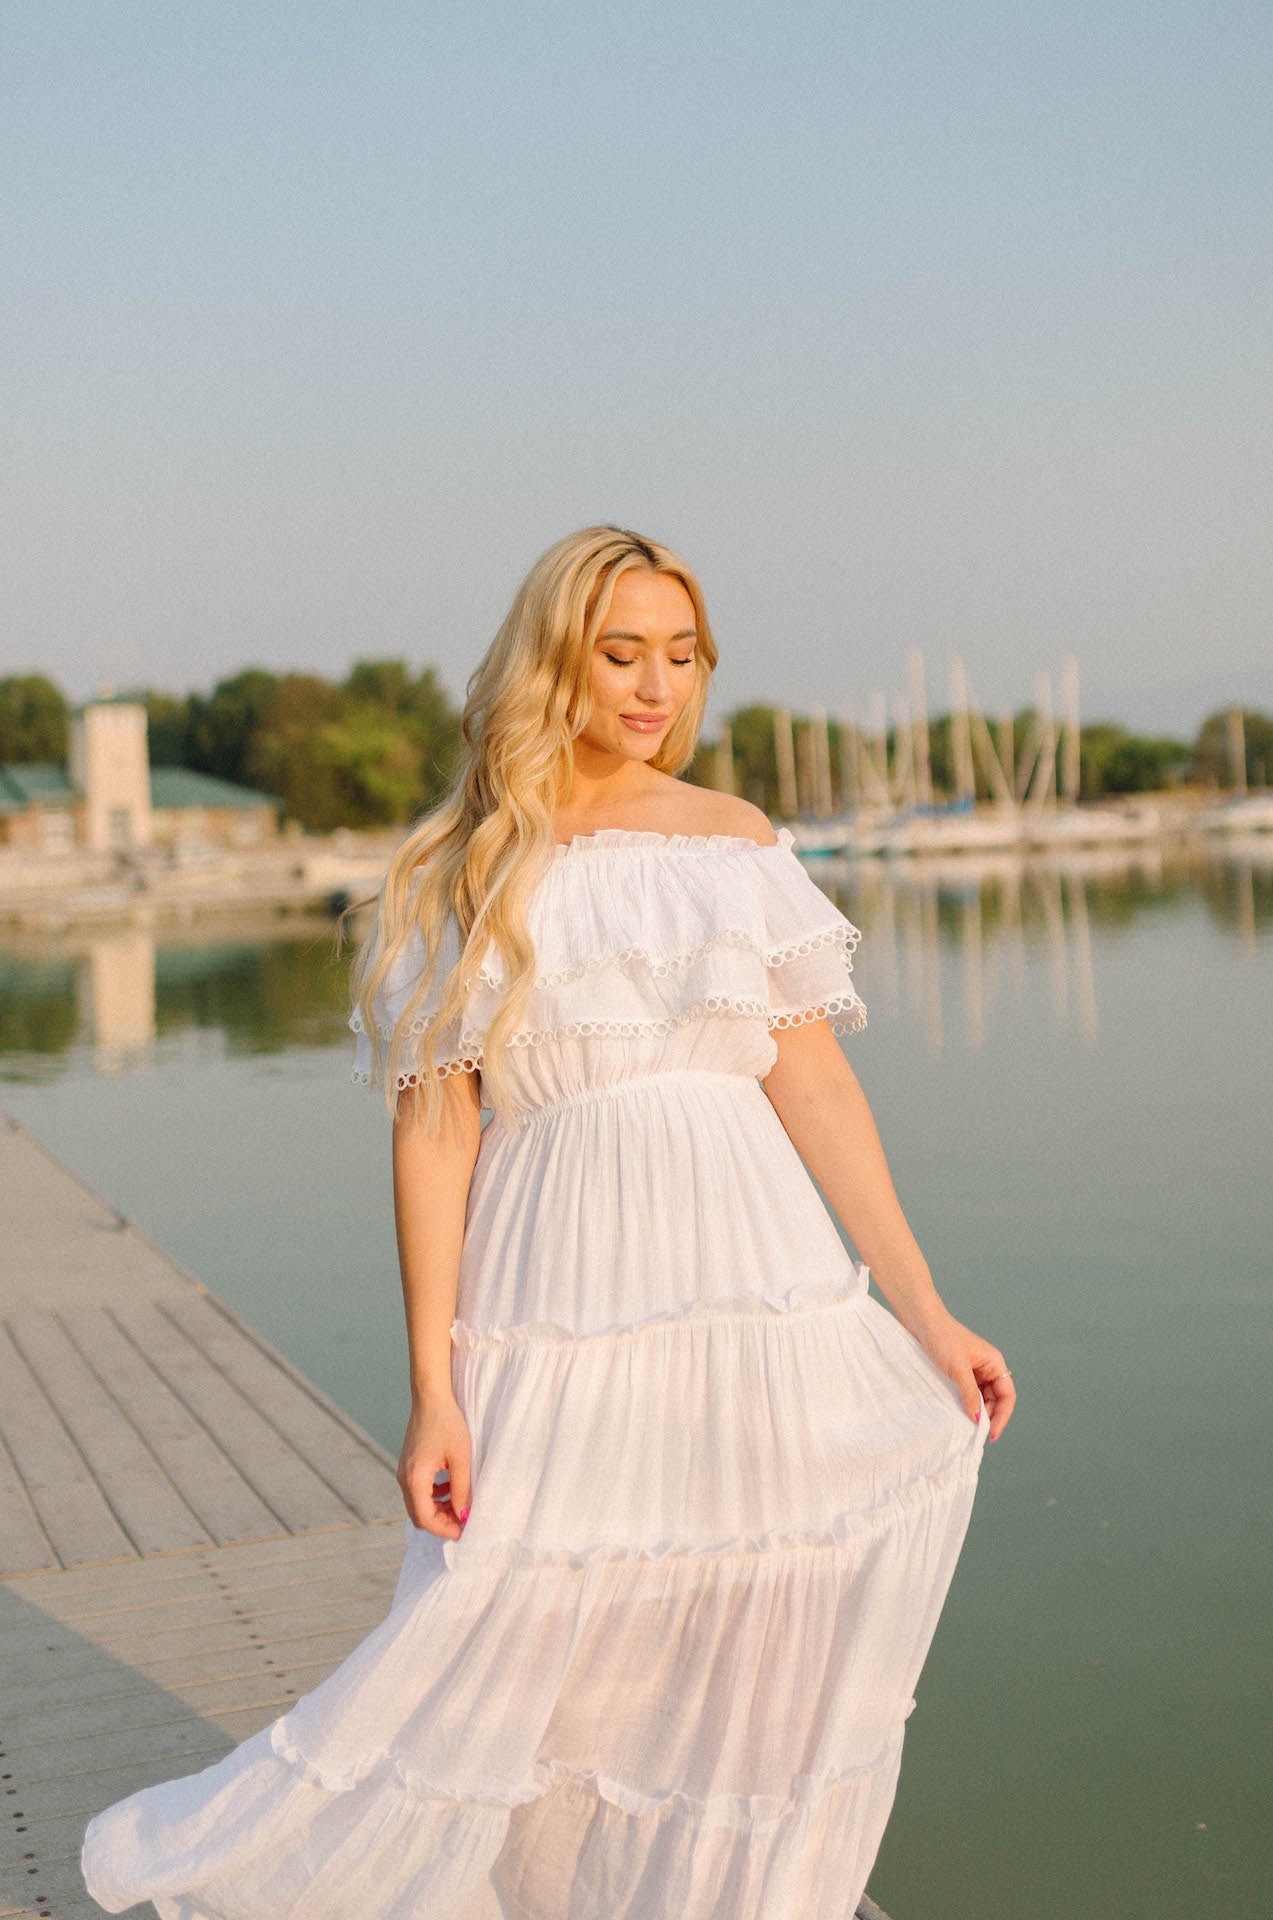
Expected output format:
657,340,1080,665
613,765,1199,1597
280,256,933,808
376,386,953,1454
394,1073,482,1540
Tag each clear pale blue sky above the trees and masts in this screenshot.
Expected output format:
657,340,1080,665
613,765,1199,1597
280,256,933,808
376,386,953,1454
0,0,1273,728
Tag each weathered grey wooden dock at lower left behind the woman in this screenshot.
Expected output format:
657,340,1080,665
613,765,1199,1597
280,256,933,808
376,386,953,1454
0,1116,885,1920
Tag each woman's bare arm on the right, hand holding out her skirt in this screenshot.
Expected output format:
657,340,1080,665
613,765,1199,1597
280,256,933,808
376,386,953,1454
764,1020,1016,1440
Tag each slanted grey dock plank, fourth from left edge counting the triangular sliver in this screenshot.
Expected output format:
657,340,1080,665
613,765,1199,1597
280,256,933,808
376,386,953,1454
67,1308,280,1544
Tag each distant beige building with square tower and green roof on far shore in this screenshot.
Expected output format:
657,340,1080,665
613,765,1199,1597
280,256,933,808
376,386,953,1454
0,697,280,852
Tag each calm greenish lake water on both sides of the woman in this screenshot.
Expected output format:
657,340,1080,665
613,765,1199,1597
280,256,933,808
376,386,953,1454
0,849,1273,1920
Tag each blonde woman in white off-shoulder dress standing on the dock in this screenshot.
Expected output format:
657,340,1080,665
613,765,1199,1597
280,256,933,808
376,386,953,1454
84,526,1014,1920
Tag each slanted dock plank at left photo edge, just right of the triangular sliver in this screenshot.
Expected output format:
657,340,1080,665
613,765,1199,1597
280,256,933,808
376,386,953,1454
0,1327,136,1567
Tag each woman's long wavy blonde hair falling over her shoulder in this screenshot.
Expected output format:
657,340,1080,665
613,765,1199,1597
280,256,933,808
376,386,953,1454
342,526,716,1133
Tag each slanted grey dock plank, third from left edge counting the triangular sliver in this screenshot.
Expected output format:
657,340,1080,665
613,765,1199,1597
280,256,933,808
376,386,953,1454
8,1309,211,1553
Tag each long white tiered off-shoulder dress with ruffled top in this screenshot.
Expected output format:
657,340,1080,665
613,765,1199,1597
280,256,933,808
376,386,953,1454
83,828,989,1920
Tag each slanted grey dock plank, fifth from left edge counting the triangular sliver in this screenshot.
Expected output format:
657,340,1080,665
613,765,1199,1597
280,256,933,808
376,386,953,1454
113,1300,357,1532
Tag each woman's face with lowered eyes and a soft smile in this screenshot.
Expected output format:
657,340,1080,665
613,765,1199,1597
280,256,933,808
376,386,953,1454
580,566,697,760
